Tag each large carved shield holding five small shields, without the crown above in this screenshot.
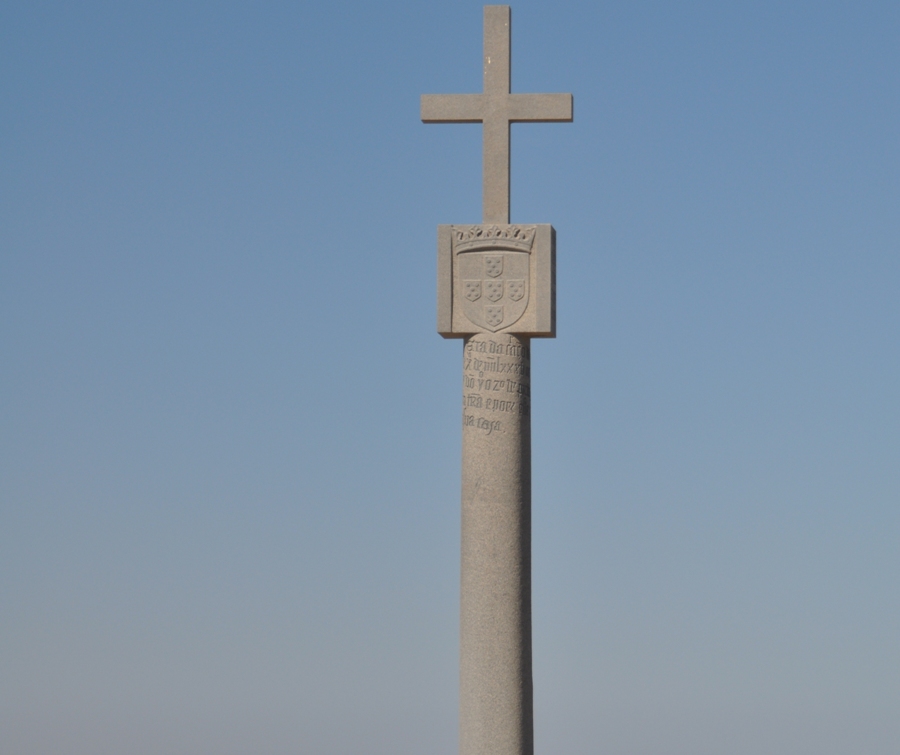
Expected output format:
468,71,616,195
457,249,531,333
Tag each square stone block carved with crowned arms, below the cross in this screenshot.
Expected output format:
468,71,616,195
438,223,556,338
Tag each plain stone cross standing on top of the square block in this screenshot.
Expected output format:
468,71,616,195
422,5,572,223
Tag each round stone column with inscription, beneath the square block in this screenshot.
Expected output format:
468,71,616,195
460,333,534,755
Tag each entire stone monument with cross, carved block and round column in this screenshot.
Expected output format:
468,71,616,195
422,5,572,755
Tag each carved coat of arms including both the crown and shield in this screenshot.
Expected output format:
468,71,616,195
453,226,534,333
